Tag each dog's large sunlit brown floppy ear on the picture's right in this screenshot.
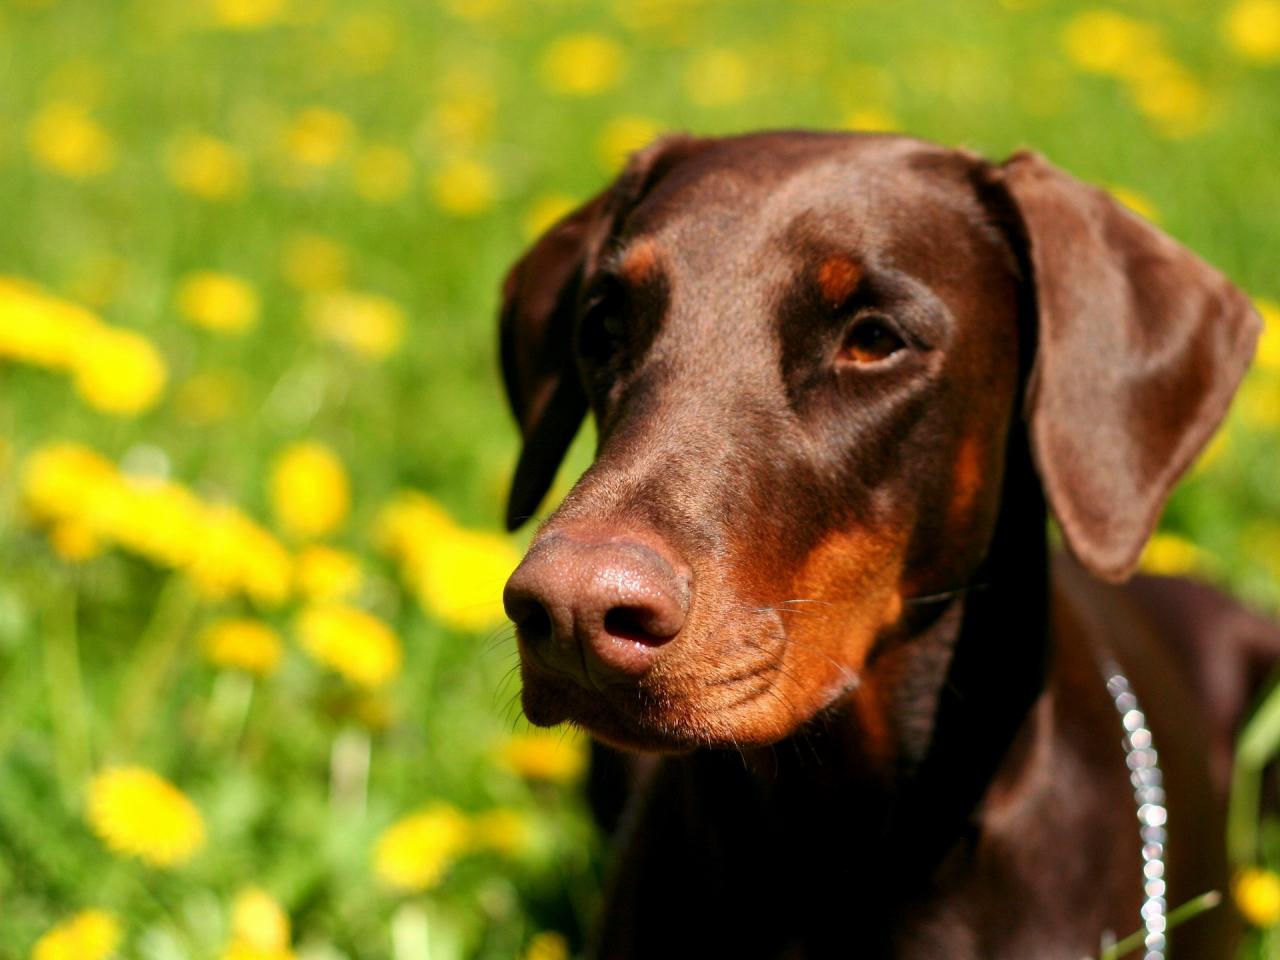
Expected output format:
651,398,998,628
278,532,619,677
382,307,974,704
995,152,1261,581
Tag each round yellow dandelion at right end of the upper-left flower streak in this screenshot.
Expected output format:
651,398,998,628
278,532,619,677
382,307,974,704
72,325,169,415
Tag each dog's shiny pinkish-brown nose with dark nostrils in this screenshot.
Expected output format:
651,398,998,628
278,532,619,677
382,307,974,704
503,534,690,685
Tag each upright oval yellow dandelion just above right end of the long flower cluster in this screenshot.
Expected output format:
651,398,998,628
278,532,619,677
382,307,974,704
270,443,351,539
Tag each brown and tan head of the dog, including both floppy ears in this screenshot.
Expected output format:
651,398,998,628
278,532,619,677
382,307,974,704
500,133,1258,750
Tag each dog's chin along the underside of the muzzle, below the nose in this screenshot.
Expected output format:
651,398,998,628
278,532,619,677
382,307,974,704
521,667,800,754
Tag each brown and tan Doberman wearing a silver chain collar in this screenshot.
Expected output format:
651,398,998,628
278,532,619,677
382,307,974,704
502,133,1280,960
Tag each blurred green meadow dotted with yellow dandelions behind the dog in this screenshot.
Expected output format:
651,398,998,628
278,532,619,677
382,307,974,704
0,0,1280,960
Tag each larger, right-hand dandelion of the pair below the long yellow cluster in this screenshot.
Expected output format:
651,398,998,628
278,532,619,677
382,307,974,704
297,603,401,687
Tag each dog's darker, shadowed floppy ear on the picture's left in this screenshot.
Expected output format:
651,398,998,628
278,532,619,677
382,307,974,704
499,136,705,530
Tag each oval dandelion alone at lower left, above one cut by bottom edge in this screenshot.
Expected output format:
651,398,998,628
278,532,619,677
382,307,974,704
88,767,205,867
